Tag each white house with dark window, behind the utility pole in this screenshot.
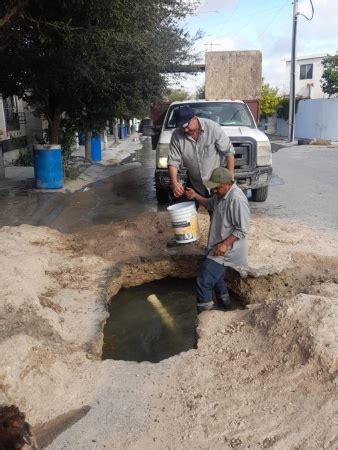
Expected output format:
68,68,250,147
285,54,328,98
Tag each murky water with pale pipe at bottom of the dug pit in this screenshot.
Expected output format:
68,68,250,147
102,278,196,362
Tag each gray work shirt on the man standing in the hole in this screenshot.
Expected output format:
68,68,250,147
207,184,250,267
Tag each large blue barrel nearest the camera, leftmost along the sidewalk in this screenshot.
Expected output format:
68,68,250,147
33,145,63,189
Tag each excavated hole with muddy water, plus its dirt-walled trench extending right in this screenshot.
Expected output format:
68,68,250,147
102,255,338,362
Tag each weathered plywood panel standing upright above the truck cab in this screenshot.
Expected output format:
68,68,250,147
205,50,262,100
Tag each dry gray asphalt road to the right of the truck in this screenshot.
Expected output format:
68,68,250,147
250,145,338,231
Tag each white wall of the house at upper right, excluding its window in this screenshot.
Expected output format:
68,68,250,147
285,55,328,98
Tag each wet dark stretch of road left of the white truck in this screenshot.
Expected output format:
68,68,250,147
0,140,164,233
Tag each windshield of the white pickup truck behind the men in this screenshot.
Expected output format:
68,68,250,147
165,102,255,128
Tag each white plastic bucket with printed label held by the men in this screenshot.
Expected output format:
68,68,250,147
167,202,200,244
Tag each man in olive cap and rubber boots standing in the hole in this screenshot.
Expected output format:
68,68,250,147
186,167,250,313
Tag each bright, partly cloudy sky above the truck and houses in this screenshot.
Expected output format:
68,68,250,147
172,0,338,93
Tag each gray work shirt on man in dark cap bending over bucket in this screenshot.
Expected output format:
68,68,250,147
168,118,235,193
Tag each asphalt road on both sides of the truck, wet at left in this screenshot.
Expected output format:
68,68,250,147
0,141,338,233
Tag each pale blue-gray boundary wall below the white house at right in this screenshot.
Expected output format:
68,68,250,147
277,97,338,141
